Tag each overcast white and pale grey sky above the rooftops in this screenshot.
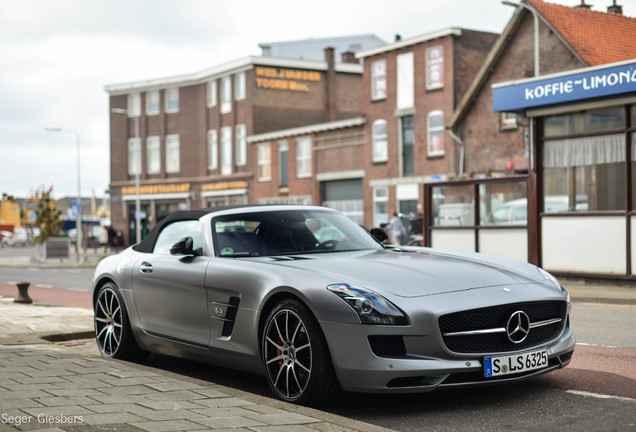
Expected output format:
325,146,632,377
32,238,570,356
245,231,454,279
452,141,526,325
0,0,636,198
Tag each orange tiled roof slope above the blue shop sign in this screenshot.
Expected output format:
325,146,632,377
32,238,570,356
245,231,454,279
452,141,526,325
529,0,636,66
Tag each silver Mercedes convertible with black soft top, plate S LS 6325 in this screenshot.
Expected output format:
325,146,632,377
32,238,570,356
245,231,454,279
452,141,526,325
93,205,575,405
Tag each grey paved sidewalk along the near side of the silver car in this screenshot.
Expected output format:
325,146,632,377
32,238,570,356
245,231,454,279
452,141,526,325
0,299,387,432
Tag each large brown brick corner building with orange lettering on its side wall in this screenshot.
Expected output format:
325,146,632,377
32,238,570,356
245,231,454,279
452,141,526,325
106,49,362,242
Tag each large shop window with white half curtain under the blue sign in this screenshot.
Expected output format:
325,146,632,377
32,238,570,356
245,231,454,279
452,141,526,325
543,106,636,213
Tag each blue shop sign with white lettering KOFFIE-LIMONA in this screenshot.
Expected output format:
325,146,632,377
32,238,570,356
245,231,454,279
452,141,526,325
492,60,636,112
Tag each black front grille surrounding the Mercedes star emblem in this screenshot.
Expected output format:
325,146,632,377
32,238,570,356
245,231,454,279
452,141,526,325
439,302,567,353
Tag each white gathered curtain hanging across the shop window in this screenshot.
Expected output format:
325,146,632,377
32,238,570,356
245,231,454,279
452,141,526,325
543,134,636,168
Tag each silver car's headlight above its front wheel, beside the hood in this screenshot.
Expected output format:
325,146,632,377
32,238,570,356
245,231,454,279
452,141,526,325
327,284,408,325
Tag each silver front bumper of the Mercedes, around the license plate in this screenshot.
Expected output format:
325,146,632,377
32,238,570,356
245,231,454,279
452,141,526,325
320,317,575,393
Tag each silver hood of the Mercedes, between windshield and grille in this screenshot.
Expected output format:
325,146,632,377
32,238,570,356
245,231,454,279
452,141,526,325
261,249,539,297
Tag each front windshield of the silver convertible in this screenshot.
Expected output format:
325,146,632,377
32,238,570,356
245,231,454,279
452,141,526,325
212,210,382,257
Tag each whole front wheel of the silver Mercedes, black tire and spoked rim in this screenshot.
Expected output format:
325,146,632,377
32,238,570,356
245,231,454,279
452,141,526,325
261,299,340,406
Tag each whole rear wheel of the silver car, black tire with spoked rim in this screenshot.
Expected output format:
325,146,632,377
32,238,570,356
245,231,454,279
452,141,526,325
94,283,148,361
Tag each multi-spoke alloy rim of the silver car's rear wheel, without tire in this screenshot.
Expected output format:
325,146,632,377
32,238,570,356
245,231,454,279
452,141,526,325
95,288,122,357
